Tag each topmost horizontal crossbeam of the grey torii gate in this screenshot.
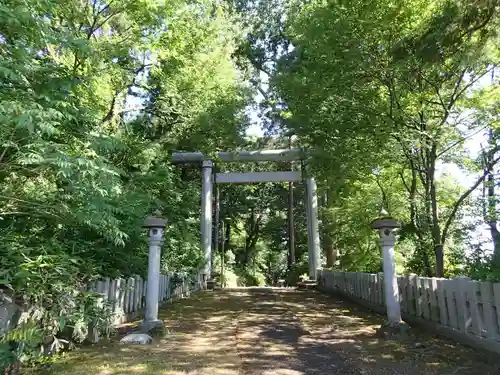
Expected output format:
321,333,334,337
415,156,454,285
172,148,307,163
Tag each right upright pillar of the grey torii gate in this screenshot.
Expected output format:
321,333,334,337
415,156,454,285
306,177,321,280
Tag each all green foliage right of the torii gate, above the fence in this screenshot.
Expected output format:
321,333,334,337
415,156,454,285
232,0,500,278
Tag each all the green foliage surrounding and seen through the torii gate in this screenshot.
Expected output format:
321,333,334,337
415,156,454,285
0,0,500,372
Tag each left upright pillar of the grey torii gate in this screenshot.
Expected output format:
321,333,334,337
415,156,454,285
200,160,213,281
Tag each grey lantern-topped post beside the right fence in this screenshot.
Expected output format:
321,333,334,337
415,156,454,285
371,210,409,338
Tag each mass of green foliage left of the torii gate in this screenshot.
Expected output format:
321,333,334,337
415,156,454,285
0,0,254,368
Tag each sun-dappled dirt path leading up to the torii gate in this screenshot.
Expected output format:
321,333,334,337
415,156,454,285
42,289,500,375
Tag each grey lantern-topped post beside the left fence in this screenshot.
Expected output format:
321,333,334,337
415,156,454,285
143,211,166,331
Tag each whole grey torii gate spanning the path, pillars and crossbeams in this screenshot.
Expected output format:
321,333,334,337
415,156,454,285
172,149,321,280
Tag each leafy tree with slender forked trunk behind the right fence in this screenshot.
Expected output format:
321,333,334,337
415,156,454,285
274,1,498,276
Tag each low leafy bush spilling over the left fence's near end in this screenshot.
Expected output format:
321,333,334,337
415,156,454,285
0,254,113,367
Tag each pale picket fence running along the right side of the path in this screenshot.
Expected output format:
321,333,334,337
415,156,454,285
319,271,500,351
